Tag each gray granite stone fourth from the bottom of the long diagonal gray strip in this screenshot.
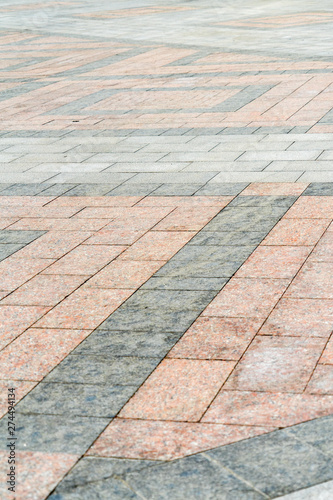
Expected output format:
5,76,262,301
72,330,179,359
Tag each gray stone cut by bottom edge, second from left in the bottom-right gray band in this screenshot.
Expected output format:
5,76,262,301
125,455,267,500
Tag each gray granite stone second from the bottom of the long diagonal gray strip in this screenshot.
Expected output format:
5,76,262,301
16,383,137,418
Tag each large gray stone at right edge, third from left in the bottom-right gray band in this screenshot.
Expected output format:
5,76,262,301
206,431,333,498
